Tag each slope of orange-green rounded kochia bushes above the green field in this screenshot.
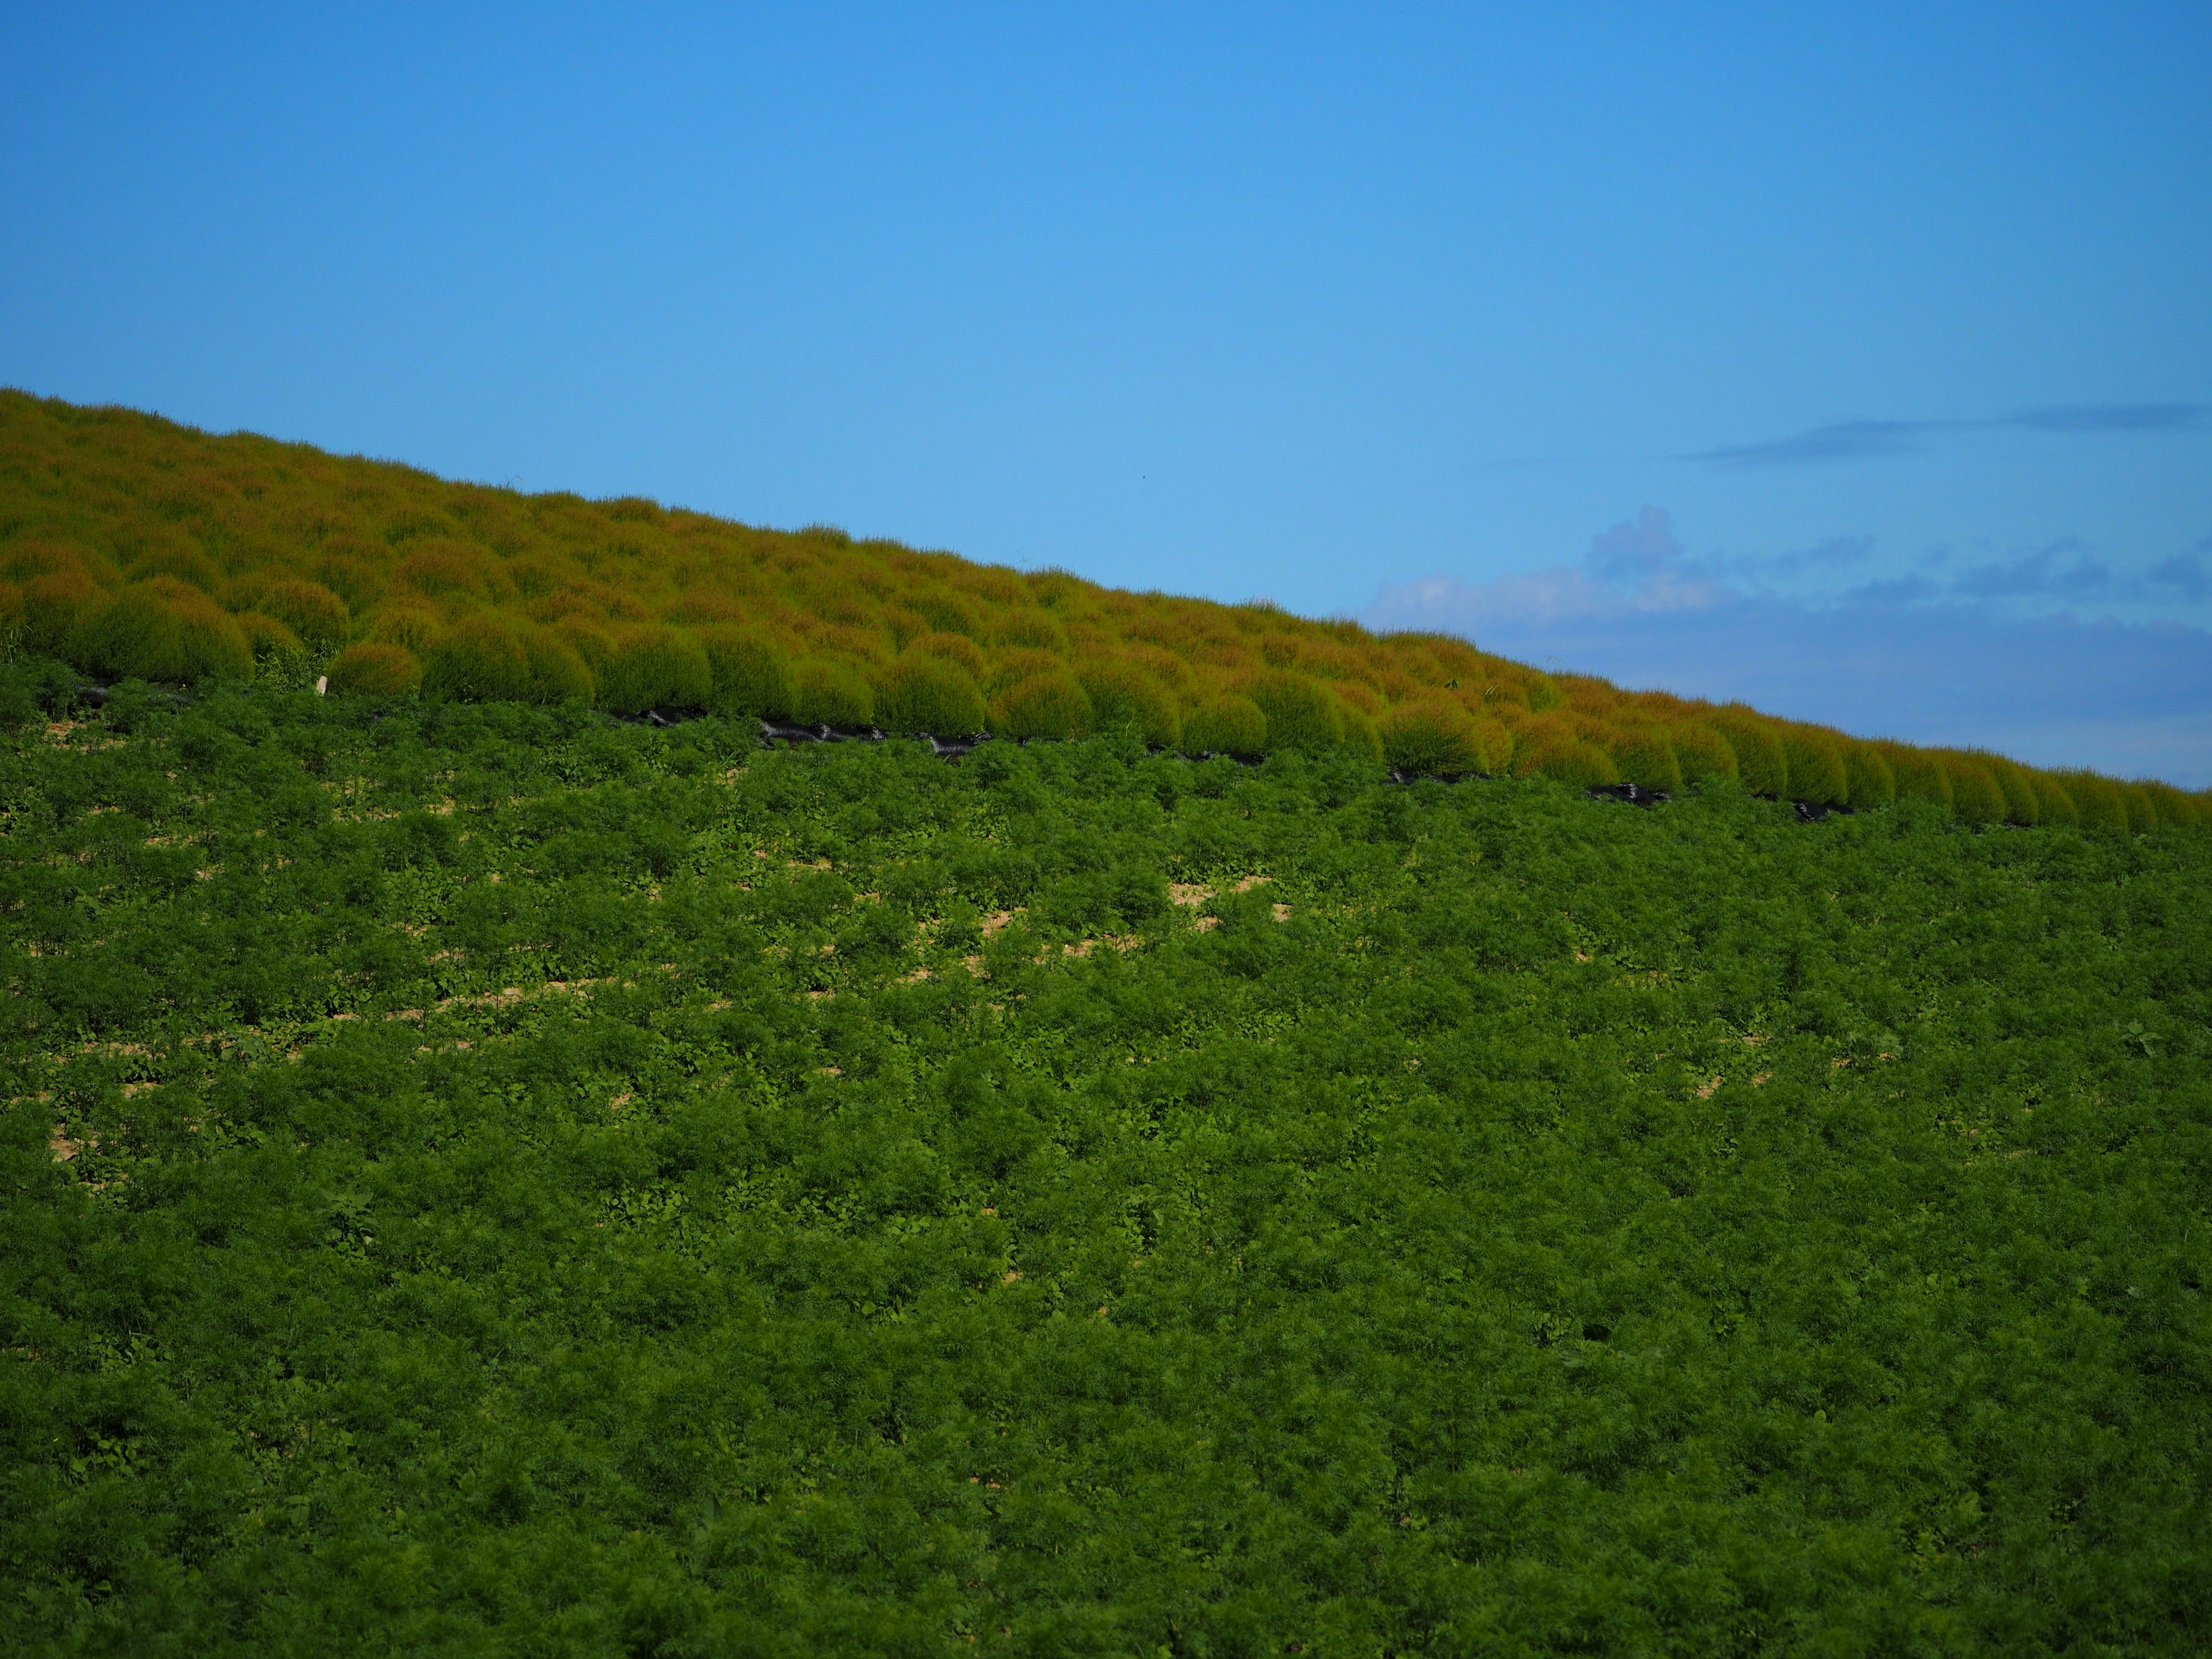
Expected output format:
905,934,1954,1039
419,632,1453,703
0,392,2212,832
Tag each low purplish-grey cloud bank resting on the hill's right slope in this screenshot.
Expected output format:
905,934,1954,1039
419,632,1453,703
1361,506,2212,785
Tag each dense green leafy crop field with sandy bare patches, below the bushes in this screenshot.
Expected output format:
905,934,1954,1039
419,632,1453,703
0,688,2212,1657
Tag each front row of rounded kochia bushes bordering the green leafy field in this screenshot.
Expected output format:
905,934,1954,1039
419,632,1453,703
0,577,2212,832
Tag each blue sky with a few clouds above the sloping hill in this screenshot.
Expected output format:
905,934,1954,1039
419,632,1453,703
0,5,2212,785
